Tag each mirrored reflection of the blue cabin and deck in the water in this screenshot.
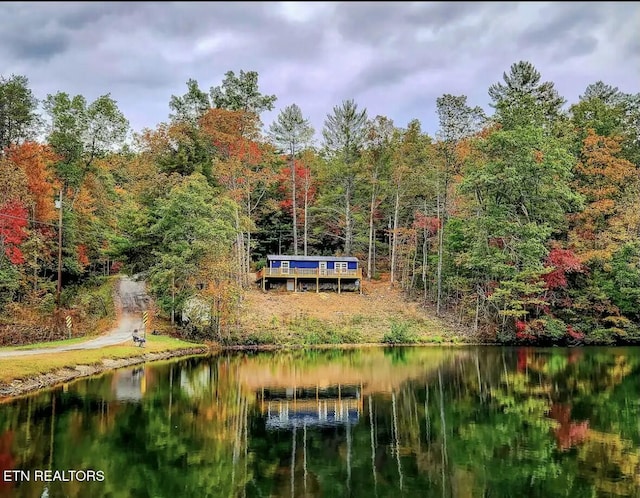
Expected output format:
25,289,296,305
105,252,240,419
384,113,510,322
257,385,362,430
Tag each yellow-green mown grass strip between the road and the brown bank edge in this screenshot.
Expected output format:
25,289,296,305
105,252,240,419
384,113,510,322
0,336,207,384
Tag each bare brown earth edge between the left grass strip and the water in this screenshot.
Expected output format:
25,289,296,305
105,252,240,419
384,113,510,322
0,347,209,402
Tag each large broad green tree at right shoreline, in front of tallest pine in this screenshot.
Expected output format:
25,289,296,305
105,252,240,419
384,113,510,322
461,126,581,338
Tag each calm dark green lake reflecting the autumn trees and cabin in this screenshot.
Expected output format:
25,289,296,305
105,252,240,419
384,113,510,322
0,347,640,498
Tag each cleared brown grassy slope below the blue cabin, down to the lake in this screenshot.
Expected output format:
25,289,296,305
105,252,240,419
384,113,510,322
239,279,464,344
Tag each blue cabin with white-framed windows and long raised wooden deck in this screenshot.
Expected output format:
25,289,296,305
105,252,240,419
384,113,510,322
256,255,362,294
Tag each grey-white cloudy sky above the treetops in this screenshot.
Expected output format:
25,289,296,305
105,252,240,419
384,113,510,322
0,2,640,140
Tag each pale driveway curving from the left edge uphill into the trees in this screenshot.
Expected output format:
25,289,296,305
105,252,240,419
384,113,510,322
0,276,149,358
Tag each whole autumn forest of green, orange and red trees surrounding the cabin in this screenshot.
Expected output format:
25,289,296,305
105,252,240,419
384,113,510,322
0,61,640,345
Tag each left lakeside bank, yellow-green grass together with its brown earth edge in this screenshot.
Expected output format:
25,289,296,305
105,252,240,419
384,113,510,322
0,336,208,397
